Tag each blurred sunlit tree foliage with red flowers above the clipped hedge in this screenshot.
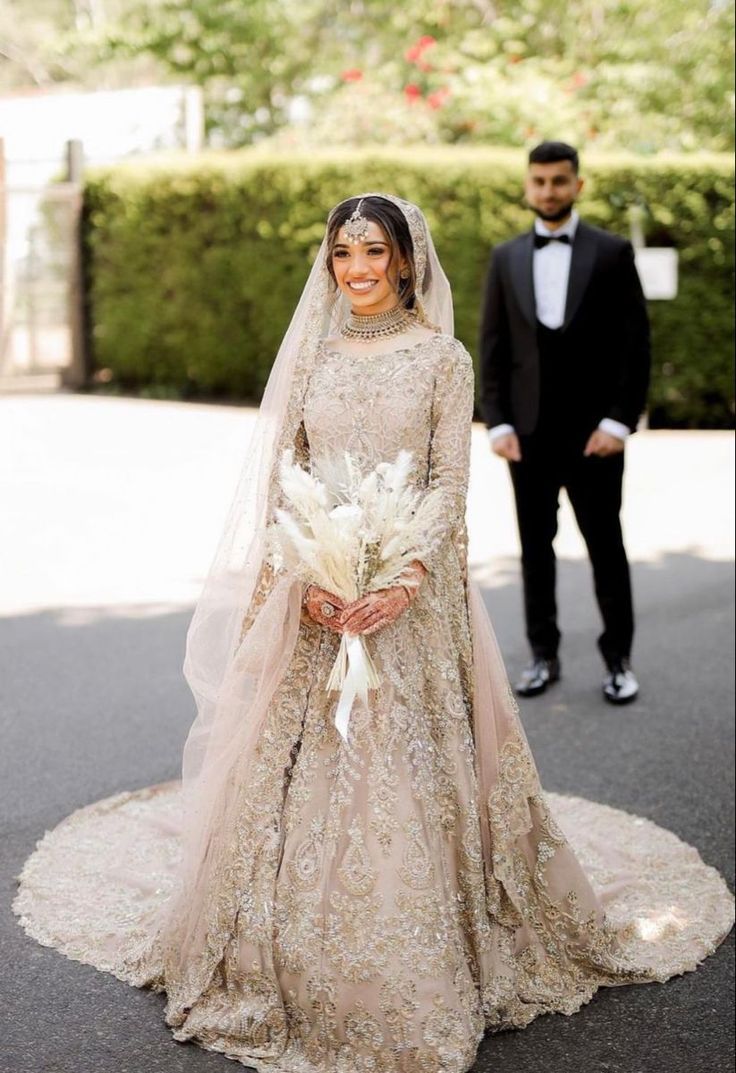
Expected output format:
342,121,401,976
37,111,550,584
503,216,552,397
0,0,734,152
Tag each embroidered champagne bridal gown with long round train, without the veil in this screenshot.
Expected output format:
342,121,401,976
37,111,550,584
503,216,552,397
15,335,733,1073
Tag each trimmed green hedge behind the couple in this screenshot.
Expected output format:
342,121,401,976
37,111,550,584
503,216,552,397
85,149,734,428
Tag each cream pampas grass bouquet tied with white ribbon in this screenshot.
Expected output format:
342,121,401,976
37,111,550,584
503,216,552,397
270,451,442,740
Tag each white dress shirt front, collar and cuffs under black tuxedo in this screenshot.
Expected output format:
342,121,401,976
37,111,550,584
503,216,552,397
488,209,631,443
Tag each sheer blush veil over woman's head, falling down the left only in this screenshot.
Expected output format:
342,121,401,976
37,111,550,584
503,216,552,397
156,193,461,987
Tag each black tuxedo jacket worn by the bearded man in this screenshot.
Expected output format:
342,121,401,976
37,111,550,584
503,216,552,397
480,221,650,436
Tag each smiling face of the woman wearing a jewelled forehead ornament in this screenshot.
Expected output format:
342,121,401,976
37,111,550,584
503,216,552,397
333,220,403,317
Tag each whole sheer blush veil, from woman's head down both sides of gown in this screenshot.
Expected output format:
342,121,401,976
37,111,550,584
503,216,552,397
136,194,609,1004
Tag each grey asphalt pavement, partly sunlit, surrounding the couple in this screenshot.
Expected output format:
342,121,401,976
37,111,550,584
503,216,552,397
0,396,734,1073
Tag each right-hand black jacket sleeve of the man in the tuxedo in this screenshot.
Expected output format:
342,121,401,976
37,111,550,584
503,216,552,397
606,242,651,431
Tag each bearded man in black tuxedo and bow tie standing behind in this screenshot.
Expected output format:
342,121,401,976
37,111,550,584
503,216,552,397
481,142,649,704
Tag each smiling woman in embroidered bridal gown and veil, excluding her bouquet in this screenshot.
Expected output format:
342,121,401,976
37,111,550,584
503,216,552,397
15,194,733,1073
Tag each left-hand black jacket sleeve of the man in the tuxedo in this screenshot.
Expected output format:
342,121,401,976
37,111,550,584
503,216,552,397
480,251,513,428
